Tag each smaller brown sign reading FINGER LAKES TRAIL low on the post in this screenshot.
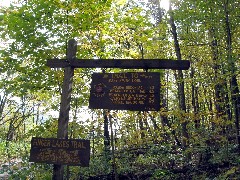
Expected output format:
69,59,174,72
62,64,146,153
29,137,90,167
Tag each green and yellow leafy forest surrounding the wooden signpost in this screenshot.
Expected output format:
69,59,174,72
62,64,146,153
0,0,240,179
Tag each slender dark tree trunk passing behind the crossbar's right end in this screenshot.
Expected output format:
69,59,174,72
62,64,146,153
169,1,189,147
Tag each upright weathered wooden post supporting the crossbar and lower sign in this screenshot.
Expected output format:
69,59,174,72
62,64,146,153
52,39,77,180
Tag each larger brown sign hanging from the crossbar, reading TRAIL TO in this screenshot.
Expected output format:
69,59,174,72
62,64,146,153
89,72,160,111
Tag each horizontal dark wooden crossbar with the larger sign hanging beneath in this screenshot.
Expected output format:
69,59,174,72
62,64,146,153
46,59,190,70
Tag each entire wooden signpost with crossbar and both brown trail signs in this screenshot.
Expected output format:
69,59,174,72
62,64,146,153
37,39,190,180
